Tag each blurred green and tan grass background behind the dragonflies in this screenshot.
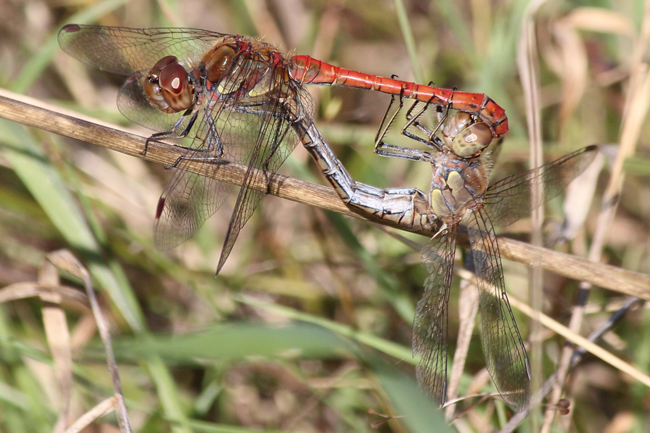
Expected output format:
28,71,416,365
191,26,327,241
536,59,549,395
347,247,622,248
0,0,650,432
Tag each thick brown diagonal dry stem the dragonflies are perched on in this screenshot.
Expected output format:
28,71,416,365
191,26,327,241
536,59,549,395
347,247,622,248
0,89,650,301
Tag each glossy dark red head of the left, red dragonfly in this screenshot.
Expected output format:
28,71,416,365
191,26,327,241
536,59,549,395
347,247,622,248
144,56,194,113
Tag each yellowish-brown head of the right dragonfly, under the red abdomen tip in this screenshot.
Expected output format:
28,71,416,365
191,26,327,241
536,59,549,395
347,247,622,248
442,113,492,158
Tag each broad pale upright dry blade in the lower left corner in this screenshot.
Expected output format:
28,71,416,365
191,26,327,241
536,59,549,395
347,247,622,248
38,262,72,433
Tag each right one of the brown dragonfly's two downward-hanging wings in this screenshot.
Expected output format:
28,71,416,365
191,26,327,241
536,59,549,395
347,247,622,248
467,210,530,411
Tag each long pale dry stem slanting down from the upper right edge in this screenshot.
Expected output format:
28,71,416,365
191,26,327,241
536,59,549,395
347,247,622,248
542,1,650,433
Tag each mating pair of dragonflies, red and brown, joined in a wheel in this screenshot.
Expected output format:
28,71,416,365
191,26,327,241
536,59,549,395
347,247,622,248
59,24,595,410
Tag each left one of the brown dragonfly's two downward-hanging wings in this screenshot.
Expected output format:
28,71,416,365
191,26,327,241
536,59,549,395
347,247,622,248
412,228,456,405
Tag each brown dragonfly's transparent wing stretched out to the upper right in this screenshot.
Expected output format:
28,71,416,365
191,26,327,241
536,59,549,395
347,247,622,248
483,146,598,226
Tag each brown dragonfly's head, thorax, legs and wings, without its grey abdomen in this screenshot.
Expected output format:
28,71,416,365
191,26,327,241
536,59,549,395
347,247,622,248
375,98,598,411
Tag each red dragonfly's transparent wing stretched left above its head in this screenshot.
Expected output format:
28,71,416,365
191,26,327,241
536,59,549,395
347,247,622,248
59,24,228,75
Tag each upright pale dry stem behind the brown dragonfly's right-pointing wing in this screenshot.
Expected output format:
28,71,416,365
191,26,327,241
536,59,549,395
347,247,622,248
517,0,545,431
